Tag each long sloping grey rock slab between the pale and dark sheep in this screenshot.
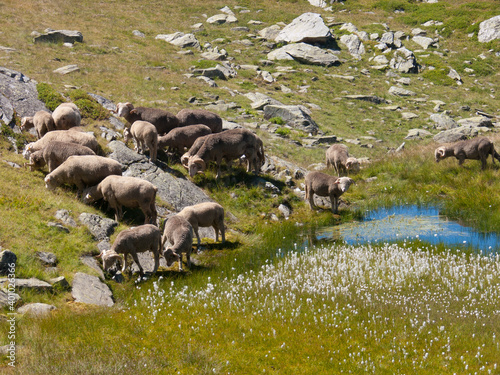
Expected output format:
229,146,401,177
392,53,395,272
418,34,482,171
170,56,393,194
108,141,211,211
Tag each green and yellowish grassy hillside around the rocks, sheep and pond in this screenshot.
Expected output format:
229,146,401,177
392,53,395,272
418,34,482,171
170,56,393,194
0,0,500,374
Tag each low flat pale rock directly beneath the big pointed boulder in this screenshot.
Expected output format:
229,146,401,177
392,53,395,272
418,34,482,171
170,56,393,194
267,43,340,66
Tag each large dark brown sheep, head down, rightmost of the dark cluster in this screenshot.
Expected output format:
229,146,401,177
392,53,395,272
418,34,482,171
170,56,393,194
188,128,257,179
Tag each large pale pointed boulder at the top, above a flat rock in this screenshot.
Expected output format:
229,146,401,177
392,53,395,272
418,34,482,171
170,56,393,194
274,13,332,44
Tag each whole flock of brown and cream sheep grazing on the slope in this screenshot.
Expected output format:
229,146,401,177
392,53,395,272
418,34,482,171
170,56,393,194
16,103,500,277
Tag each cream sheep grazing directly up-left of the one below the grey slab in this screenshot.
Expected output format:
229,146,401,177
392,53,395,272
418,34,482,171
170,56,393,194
45,155,122,195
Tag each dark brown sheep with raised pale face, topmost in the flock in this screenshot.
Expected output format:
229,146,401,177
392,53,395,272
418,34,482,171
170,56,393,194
114,102,179,135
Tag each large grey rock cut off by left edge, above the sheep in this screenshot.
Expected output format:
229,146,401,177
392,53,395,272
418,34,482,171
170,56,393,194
0,67,48,125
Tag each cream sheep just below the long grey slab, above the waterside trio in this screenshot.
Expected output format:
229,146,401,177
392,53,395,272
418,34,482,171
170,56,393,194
83,175,158,224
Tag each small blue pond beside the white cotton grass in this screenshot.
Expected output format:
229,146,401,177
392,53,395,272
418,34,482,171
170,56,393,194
316,206,500,253
